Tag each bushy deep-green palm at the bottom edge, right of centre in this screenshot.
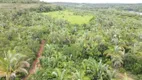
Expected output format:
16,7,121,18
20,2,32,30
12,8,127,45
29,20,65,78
82,57,115,80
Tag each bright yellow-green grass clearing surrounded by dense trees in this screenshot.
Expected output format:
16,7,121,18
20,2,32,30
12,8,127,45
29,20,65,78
43,11,93,25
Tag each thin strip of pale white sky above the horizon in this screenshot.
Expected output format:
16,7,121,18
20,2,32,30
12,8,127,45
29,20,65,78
41,0,142,3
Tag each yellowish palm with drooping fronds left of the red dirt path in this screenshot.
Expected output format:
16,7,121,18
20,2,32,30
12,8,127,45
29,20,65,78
0,51,30,80
